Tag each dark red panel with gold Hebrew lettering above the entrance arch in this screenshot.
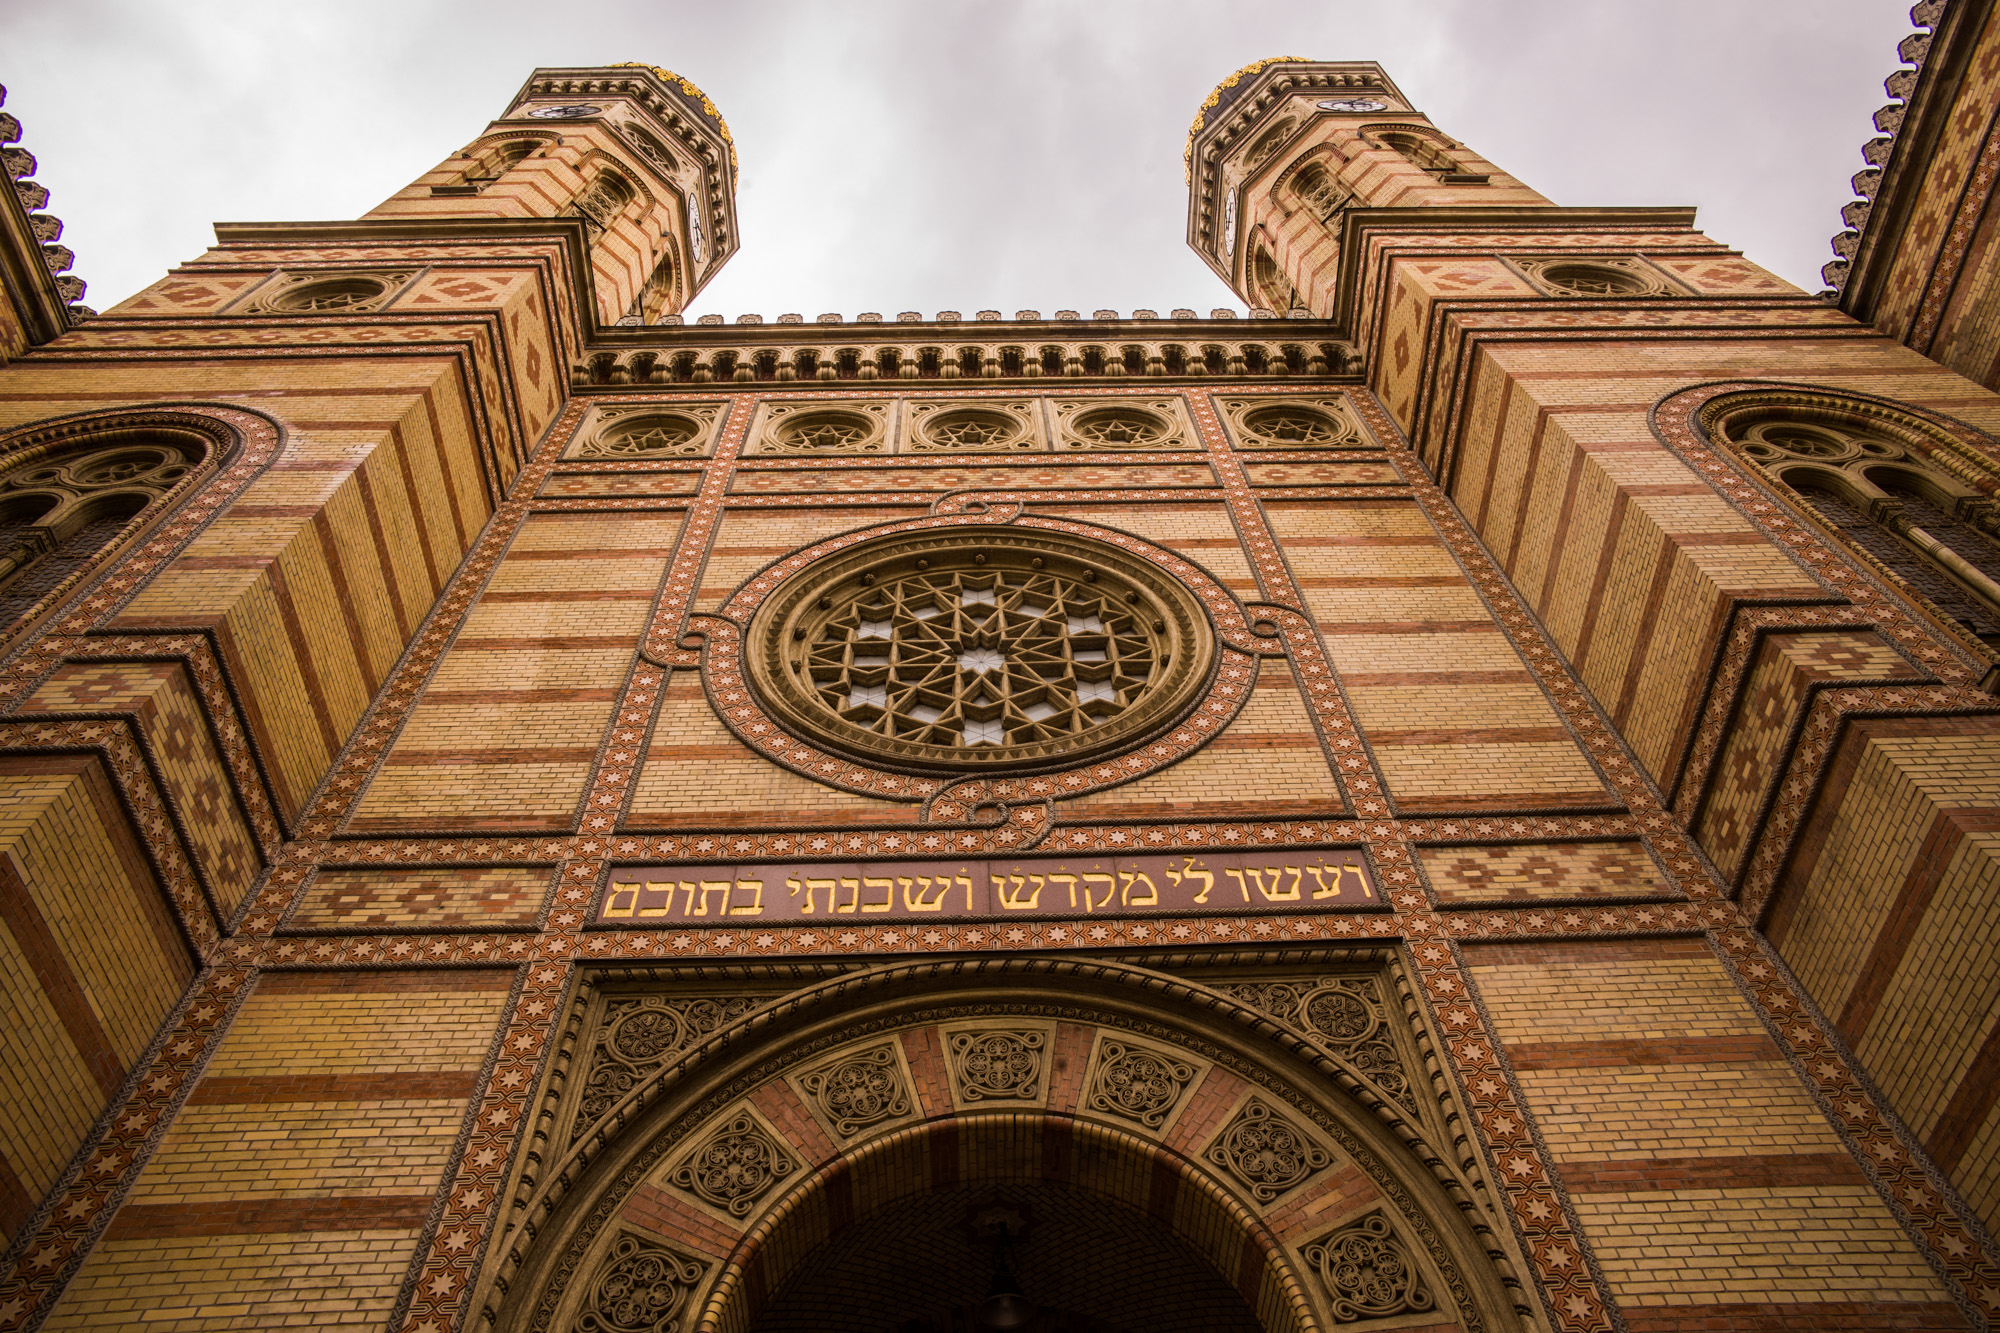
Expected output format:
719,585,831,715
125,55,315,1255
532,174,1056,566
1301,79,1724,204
596,849,1382,927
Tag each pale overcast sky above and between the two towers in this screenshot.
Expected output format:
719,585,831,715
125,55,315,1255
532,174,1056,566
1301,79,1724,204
0,0,1910,318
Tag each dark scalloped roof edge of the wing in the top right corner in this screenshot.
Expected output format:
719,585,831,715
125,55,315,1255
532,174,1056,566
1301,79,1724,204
1820,0,1994,324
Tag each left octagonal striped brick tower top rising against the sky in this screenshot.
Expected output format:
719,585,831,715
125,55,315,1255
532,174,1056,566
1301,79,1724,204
368,64,738,324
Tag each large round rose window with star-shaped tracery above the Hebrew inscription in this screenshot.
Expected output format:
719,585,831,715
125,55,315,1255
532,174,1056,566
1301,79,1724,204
748,526,1214,773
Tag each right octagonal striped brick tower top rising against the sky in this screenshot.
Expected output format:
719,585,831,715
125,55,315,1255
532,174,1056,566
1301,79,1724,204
1186,56,1552,318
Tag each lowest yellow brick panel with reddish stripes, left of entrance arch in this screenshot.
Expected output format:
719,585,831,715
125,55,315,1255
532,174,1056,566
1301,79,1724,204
44,971,514,1329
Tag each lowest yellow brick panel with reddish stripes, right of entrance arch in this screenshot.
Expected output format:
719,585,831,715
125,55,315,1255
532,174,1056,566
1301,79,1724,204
1466,941,1956,1333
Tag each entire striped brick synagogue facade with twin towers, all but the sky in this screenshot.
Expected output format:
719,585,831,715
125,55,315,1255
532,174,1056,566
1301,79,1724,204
0,4,2000,1333
